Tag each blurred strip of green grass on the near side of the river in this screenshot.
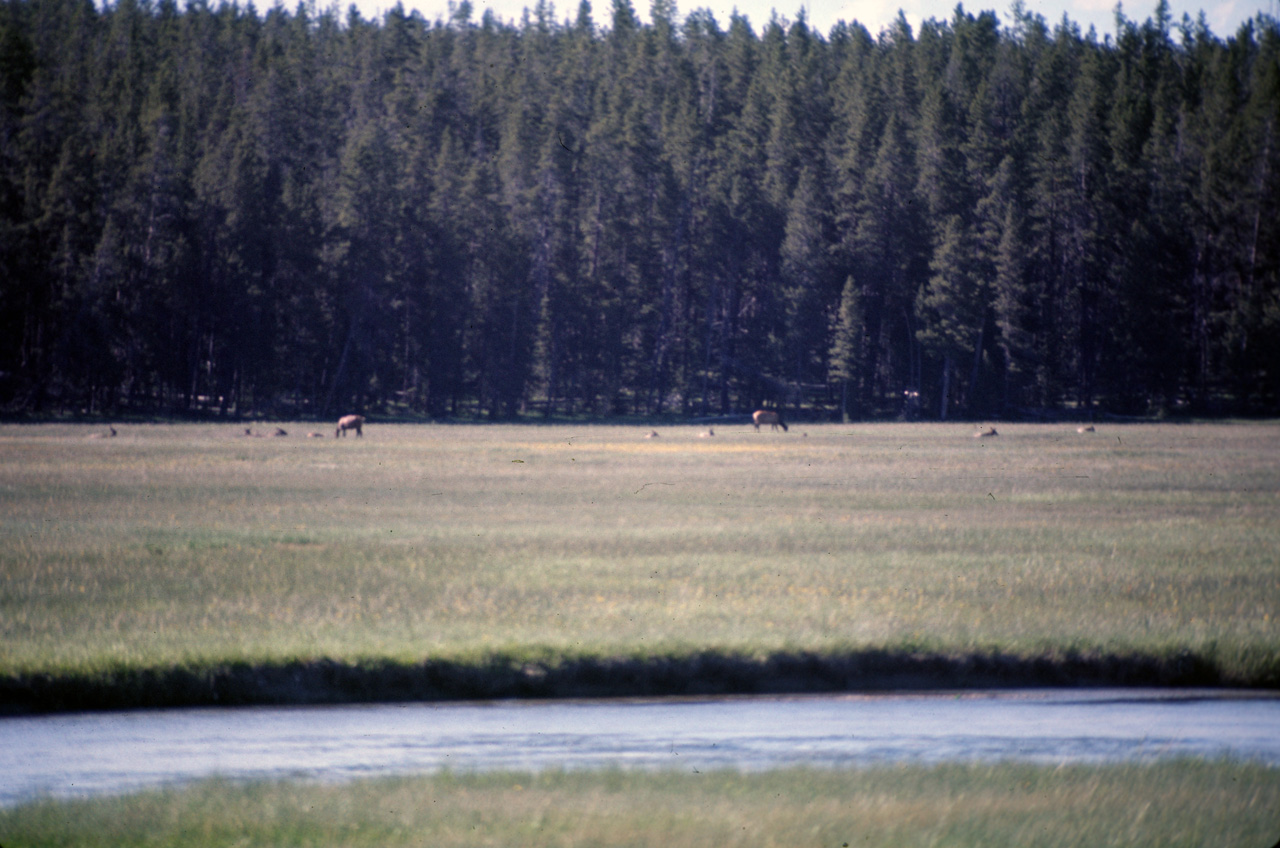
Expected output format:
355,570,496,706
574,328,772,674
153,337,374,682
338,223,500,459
0,761,1280,848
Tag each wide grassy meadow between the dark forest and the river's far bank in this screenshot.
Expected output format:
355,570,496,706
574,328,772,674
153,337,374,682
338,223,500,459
0,423,1280,680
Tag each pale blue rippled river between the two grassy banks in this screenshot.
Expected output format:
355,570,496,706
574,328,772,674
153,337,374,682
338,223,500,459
0,689,1280,806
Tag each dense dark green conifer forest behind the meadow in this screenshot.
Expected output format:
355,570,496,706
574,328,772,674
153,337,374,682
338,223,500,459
0,0,1280,420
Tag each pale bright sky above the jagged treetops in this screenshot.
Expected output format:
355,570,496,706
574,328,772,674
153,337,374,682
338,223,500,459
345,0,1280,38
